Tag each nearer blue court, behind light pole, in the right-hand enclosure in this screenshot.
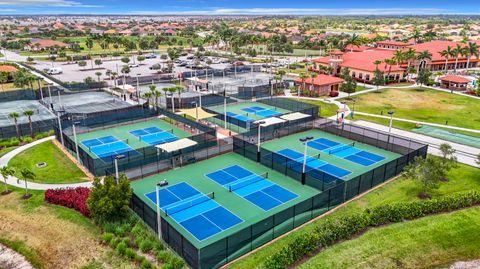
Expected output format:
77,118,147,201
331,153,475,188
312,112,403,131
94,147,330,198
277,148,352,178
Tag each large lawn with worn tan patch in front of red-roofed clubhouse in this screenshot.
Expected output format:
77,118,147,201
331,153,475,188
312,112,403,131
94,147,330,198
344,88,480,129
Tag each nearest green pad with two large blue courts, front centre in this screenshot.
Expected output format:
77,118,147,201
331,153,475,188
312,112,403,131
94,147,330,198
131,153,320,248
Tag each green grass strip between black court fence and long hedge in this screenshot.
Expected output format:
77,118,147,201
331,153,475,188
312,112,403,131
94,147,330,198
230,161,480,268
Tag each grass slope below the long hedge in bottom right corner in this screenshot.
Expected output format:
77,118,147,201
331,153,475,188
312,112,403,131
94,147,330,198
299,207,480,268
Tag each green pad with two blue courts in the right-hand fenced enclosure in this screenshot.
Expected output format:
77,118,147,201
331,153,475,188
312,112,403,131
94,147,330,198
262,130,401,180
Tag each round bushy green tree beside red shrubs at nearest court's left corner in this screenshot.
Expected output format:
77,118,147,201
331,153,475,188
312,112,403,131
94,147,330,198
87,174,132,223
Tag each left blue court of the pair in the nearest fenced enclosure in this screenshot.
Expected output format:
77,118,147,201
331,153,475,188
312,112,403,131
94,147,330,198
145,182,243,241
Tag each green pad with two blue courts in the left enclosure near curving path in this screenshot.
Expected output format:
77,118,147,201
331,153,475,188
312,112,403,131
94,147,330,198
72,118,191,160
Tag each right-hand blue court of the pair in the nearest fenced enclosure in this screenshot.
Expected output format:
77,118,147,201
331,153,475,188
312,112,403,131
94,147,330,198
207,165,298,211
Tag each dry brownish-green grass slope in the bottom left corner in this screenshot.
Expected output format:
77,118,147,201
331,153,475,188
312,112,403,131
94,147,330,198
0,185,137,269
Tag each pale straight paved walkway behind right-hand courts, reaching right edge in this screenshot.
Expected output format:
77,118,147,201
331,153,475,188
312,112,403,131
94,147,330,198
354,120,480,167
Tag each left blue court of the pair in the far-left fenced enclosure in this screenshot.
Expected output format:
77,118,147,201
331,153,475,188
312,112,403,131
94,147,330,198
81,135,139,161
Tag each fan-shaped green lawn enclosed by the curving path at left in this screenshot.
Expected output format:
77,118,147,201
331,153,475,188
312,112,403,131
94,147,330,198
9,141,86,183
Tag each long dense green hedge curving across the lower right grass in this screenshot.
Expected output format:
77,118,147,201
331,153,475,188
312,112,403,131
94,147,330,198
263,191,480,269
